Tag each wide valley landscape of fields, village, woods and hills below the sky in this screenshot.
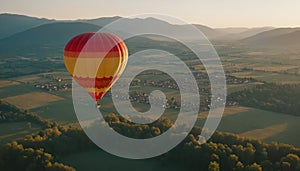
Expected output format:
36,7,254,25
0,14,300,171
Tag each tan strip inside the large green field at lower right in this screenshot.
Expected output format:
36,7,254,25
240,123,288,140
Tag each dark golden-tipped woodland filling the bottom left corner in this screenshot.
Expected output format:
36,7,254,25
0,126,97,171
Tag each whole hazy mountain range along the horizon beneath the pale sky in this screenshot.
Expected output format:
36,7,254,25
0,13,300,56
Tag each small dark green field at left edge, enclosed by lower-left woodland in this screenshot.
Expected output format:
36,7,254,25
0,122,41,144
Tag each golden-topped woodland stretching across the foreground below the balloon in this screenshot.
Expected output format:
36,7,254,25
0,109,300,171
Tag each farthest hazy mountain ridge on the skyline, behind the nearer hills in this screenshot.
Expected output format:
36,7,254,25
0,13,271,40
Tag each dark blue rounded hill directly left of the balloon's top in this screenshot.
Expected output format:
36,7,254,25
0,22,100,56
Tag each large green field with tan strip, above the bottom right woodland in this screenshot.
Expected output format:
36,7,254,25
198,107,300,147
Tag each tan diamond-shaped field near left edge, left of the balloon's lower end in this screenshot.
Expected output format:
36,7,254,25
3,92,64,110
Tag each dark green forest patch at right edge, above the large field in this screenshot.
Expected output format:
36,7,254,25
227,83,300,116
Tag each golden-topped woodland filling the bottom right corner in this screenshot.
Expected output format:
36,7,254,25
163,127,300,171
